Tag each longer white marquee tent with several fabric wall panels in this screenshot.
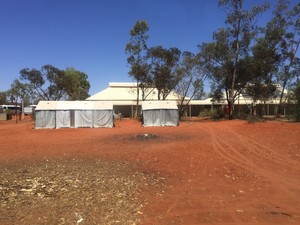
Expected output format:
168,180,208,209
35,101,114,128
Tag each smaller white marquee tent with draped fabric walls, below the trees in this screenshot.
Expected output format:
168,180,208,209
142,101,179,127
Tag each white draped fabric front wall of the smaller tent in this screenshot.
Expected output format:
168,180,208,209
143,109,179,127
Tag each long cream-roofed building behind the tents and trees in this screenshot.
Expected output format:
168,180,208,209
86,82,291,117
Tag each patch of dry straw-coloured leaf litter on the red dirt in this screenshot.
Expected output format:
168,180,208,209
0,159,164,225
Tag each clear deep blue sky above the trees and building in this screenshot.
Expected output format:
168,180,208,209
0,0,296,95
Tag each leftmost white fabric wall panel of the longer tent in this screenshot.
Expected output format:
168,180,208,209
35,110,55,128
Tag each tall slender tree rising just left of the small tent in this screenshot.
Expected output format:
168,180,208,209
125,20,151,117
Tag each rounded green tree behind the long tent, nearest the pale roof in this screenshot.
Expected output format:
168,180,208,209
64,67,90,101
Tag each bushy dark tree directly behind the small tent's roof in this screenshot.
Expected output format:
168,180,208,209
148,46,181,100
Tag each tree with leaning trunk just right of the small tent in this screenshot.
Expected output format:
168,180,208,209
175,52,206,118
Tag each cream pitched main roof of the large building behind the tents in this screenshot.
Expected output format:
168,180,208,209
86,82,186,101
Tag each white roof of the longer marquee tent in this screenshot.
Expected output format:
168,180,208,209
35,101,113,110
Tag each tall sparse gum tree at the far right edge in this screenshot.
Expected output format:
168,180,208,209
264,0,300,110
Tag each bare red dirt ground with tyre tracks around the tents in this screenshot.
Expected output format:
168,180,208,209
0,119,300,225
